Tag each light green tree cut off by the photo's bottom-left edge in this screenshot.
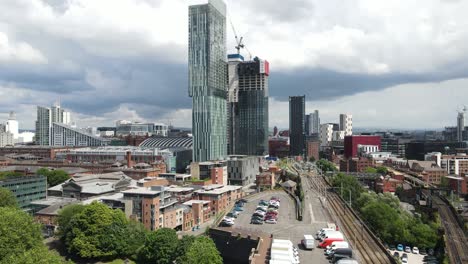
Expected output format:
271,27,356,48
0,207,42,261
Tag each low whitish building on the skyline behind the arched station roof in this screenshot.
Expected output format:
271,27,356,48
115,120,169,137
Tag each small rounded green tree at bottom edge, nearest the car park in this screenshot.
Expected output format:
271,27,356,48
182,236,223,264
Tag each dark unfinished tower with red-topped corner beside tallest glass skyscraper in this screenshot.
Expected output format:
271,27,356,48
228,54,269,155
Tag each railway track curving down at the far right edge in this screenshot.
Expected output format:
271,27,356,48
432,195,468,264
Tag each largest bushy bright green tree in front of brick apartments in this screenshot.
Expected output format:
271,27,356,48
64,202,128,259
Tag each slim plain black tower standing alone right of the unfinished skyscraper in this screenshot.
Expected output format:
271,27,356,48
289,95,305,156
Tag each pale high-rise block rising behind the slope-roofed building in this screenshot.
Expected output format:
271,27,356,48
36,105,71,146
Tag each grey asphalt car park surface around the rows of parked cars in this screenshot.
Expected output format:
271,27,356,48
225,191,329,264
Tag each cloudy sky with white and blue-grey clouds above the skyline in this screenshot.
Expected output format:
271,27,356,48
0,0,468,129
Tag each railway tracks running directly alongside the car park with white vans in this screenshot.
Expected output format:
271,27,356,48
309,176,394,264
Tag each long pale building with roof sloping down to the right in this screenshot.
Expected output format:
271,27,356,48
49,123,110,147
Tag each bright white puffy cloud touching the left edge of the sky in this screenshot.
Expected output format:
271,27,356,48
0,32,47,64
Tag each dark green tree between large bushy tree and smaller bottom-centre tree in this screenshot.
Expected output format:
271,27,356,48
138,228,179,264
